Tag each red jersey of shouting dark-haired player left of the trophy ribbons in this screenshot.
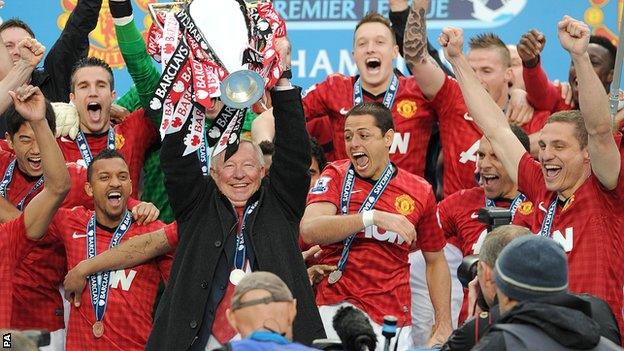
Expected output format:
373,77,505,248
57,109,159,199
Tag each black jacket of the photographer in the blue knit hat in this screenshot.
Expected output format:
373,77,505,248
473,294,613,351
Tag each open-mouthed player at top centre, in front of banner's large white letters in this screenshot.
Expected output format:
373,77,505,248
303,13,434,177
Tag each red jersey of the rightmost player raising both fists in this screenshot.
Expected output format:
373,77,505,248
518,154,624,331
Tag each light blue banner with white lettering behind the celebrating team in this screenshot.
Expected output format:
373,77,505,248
0,0,624,93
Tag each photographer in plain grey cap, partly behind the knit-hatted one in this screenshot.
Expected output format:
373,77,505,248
442,225,531,351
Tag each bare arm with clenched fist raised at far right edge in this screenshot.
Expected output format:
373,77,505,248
557,16,621,190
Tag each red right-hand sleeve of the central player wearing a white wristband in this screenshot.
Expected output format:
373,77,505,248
416,188,446,252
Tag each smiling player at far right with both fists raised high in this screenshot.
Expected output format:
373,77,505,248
440,16,624,336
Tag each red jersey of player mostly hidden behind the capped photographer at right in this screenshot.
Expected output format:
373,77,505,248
438,187,534,256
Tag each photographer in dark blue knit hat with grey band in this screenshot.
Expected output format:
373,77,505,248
473,235,621,351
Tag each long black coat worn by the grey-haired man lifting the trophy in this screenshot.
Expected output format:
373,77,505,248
147,89,325,351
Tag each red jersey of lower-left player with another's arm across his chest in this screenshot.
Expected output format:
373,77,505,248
45,207,177,350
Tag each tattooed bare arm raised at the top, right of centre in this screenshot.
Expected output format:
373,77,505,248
403,0,446,100
